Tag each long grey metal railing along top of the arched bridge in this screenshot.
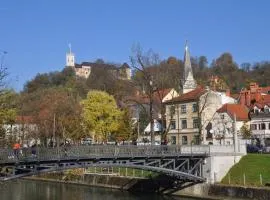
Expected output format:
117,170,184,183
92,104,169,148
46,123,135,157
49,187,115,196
0,145,210,163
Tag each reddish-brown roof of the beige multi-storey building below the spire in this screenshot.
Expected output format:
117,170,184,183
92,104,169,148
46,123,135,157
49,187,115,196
166,86,206,103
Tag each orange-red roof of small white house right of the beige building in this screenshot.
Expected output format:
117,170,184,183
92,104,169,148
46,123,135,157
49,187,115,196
217,104,248,121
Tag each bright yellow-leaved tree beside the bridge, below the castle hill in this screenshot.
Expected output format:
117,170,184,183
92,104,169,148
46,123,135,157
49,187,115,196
81,90,122,142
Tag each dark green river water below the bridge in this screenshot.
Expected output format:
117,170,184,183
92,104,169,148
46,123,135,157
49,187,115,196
0,180,205,200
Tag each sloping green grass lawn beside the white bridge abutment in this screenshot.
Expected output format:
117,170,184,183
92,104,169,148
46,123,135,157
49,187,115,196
221,154,270,186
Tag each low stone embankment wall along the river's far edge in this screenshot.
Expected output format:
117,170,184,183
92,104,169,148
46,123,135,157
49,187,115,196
26,173,270,200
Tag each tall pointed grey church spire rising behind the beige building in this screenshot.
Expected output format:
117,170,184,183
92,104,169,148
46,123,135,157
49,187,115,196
181,42,197,94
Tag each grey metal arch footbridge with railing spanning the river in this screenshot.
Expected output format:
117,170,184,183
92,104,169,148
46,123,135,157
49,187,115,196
0,145,246,184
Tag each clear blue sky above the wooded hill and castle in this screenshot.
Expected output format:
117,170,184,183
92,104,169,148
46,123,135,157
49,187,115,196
0,0,270,90
